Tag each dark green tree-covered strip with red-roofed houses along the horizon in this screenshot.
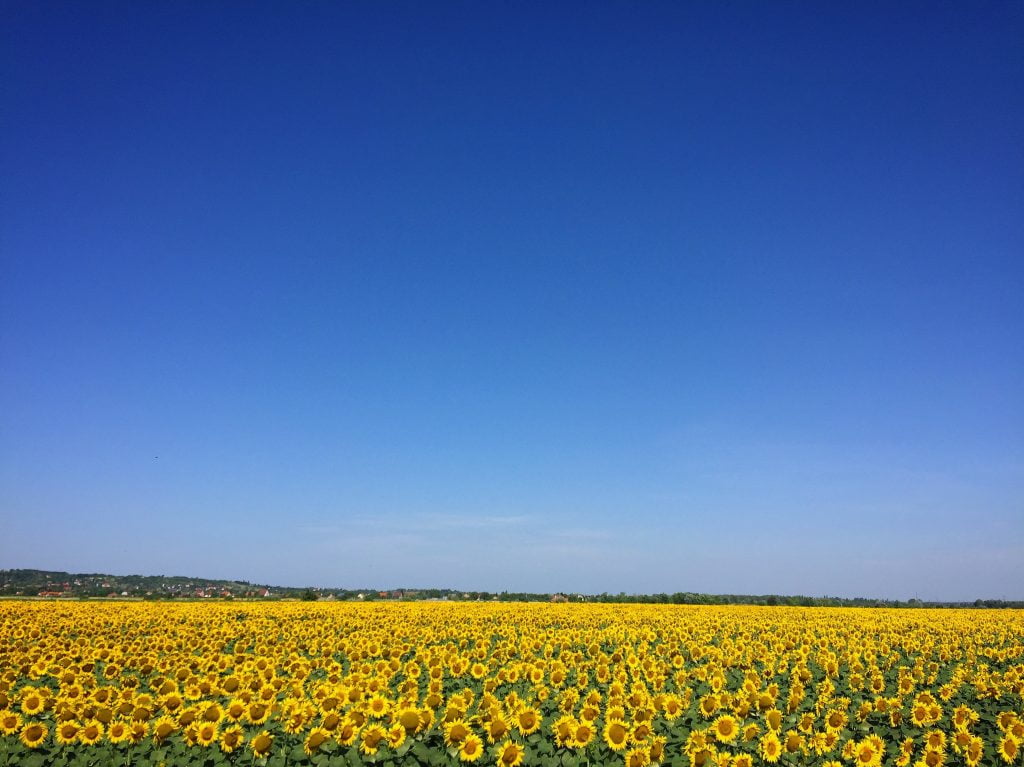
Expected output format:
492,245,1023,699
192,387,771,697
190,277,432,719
0,569,1024,608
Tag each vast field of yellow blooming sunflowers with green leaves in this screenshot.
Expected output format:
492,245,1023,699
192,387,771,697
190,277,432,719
0,601,1024,767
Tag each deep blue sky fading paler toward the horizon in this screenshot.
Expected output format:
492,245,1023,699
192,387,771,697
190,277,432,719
0,1,1024,599
